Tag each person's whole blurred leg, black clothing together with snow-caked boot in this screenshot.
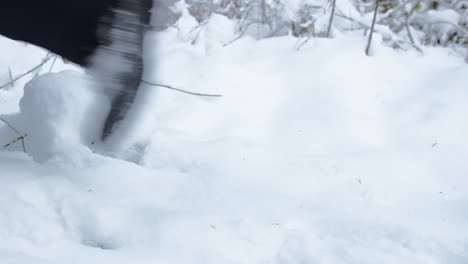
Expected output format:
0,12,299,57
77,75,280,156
0,0,152,139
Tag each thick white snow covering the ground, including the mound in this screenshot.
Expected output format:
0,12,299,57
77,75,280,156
0,18,468,264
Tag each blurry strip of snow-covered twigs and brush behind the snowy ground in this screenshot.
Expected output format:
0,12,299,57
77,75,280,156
156,0,468,60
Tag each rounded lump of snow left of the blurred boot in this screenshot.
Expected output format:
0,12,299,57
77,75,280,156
6,70,109,161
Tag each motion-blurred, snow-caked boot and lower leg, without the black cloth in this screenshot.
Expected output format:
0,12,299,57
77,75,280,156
91,0,152,140
